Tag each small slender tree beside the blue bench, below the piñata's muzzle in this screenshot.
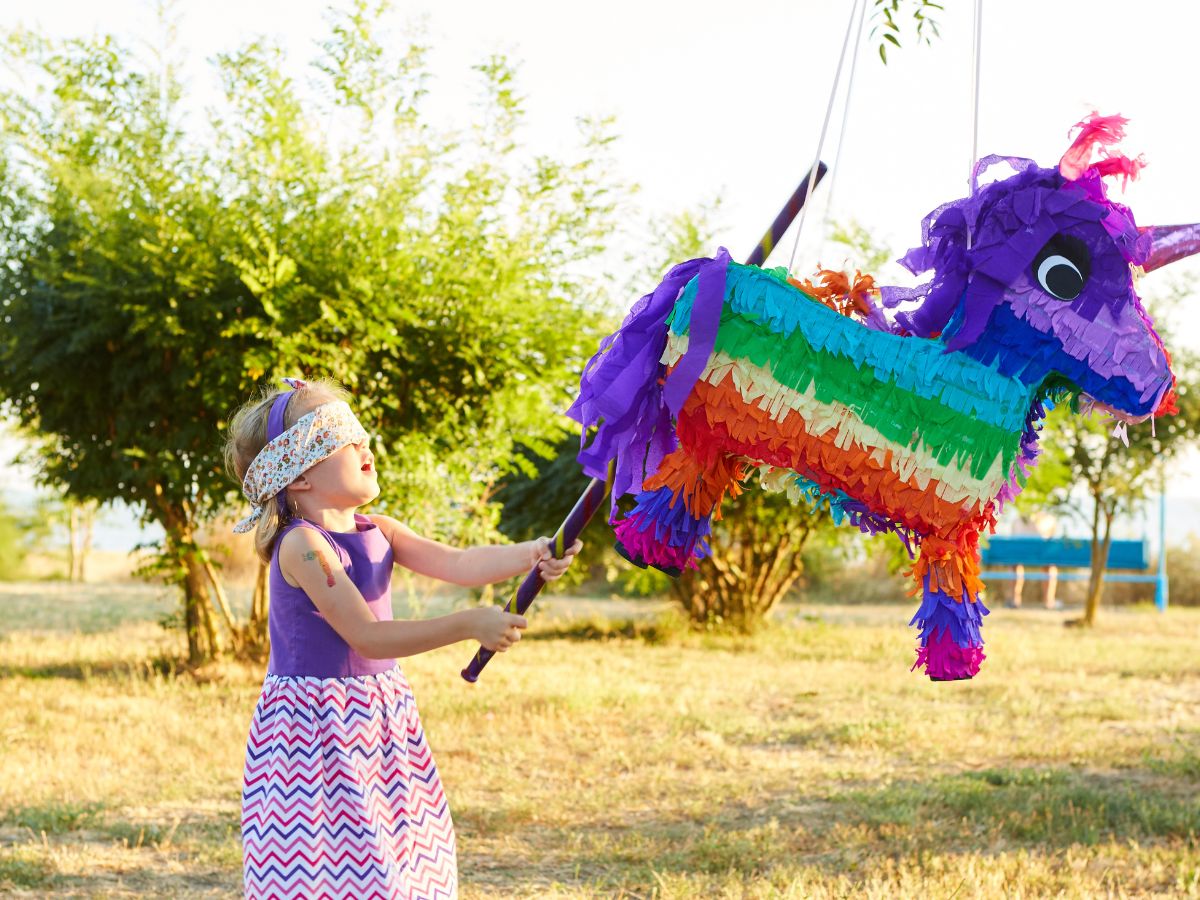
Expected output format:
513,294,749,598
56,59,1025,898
1018,283,1200,626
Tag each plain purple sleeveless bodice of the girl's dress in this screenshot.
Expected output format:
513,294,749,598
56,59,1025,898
266,512,396,678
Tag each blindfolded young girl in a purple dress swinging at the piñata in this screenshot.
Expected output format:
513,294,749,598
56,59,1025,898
226,379,581,900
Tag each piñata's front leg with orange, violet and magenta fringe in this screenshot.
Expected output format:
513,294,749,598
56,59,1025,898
908,550,988,682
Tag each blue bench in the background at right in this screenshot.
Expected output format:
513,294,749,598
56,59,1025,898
980,535,1168,610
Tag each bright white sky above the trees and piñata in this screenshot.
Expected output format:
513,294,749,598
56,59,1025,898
0,0,1200,547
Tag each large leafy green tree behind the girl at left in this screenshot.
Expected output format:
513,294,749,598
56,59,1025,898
0,0,620,662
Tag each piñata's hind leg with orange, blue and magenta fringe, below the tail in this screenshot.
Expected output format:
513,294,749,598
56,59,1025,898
613,448,746,577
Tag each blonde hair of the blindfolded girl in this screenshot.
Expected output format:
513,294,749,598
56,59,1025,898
224,378,350,563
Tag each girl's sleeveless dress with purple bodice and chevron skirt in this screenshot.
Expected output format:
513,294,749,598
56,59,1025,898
241,515,458,900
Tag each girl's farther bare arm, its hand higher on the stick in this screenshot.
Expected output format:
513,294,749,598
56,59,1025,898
368,516,583,588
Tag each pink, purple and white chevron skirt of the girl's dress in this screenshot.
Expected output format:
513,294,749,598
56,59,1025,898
241,666,458,900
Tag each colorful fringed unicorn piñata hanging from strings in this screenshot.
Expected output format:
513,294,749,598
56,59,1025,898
570,115,1198,680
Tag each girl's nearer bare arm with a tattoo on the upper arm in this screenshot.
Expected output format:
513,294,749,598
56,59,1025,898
280,528,526,659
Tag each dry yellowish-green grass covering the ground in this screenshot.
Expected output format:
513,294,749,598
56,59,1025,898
0,586,1200,899
